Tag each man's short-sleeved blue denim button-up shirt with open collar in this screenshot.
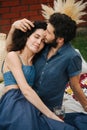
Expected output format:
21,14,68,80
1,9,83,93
34,43,82,110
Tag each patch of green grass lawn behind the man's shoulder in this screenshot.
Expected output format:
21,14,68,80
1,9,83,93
72,34,87,61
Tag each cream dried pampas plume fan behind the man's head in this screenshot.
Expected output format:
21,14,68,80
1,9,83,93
41,0,87,24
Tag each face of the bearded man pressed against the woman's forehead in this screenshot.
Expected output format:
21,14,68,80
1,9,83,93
45,23,55,44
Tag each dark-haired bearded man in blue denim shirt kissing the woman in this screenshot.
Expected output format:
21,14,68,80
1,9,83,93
7,13,87,128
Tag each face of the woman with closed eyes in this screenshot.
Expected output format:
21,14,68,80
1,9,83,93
26,29,45,53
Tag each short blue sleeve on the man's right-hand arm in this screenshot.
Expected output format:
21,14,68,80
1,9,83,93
68,55,82,77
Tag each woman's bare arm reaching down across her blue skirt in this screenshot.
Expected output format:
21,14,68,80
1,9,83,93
6,52,62,121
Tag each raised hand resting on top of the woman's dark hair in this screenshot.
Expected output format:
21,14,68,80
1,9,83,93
12,18,34,32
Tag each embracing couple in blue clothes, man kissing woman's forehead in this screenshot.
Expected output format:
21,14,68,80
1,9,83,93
0,13,87,130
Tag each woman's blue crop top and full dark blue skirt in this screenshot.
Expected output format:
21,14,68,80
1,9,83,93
0,61,76,130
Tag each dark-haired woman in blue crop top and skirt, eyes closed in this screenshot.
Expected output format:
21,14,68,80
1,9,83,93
0,22,74,130
